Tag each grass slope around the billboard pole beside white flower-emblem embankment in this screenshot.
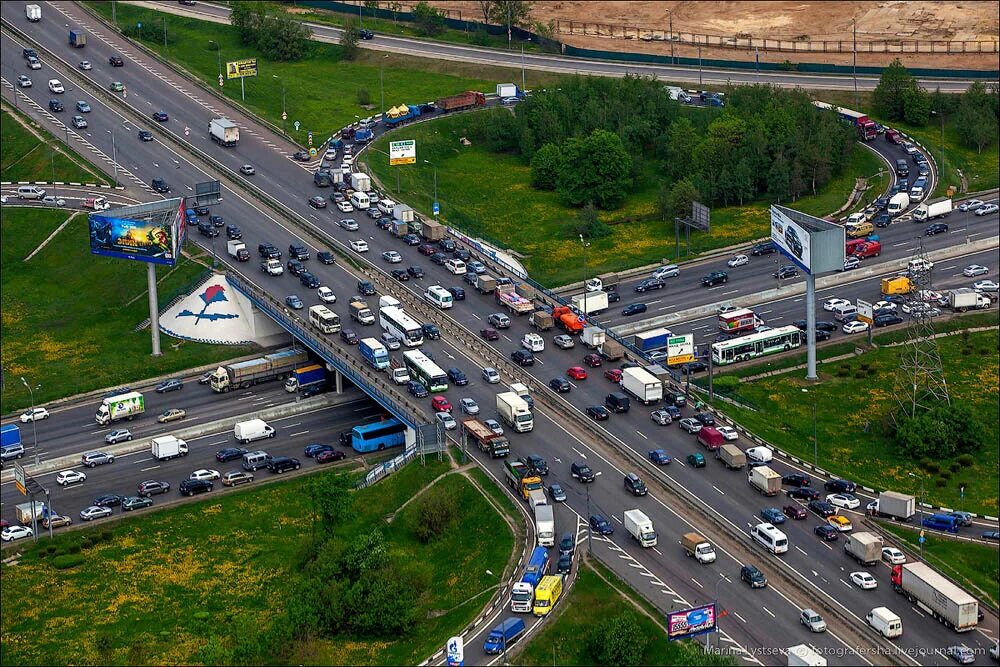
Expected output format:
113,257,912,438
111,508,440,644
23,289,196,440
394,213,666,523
0,207,249,414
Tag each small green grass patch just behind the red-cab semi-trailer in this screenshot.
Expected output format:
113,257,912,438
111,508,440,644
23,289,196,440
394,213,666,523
882,523,1000,607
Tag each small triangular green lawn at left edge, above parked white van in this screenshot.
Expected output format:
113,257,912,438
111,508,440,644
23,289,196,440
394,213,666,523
0,102,111,185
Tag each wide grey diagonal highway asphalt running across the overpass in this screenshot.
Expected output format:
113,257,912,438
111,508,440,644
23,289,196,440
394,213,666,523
0,3,996,664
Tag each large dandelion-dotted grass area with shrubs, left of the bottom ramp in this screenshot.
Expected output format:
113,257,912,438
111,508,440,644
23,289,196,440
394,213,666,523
0,461,513,665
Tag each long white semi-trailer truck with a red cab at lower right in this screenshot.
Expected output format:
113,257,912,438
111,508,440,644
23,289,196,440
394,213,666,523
889,562,979,632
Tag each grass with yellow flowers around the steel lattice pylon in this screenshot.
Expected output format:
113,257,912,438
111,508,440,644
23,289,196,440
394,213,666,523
704,326,1000,516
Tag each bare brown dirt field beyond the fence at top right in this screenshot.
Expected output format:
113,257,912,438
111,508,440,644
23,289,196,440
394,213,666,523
431,0,1000,70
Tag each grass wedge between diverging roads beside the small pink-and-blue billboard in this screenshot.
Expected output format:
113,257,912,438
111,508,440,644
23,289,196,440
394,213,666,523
513,561,735,666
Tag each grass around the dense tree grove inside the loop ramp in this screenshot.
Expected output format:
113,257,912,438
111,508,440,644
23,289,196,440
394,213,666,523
369,115,881,287
